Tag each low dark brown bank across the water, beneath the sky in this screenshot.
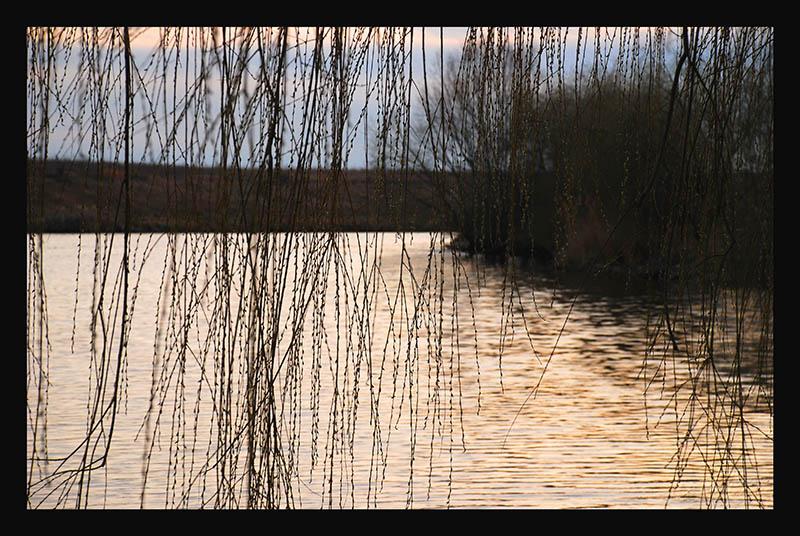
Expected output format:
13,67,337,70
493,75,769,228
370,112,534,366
26,160,455,234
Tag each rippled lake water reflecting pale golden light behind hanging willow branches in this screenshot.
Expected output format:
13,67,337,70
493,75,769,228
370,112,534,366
28,233,773,508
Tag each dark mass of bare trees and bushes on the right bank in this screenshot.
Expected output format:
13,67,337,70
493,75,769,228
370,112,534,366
416,29,774,287
